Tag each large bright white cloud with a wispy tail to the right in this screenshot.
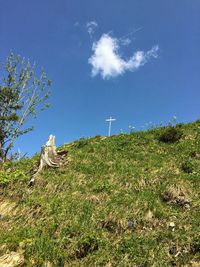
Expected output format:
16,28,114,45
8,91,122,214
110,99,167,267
88,34,159,79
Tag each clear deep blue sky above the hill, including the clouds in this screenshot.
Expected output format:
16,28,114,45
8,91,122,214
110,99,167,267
0,0,200,154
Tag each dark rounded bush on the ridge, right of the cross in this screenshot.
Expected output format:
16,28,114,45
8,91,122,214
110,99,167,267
158,126,183,143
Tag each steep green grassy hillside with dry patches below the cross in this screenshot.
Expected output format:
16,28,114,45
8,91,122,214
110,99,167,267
0,121,200,267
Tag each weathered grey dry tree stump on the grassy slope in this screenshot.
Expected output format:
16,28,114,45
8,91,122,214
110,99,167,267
29,135,67,186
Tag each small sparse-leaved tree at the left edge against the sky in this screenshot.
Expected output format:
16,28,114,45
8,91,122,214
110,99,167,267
0,53,51,161
